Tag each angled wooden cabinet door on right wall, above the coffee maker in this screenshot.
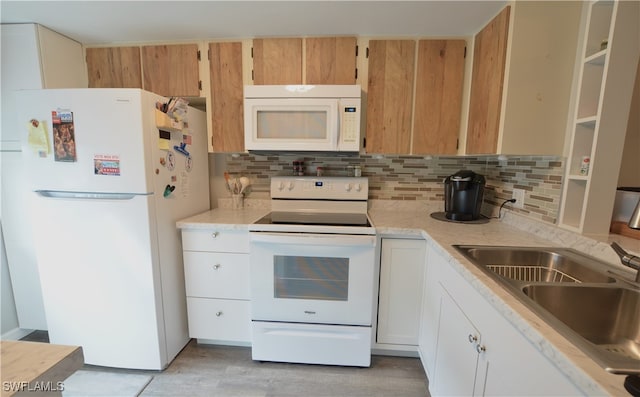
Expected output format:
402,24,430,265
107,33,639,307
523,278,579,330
466,6,510,154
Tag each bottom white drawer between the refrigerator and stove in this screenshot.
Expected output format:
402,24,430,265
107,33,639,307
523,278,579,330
187,297,251,342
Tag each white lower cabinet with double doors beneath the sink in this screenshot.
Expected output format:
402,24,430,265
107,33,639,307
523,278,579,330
419,247,582,396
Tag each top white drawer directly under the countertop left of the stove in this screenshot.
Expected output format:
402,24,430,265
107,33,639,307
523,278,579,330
182,229,249,253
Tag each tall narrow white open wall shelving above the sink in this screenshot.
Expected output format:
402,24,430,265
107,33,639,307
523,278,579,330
559,0,639,236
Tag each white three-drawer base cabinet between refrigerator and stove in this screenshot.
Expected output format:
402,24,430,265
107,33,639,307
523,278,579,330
182,230,251,345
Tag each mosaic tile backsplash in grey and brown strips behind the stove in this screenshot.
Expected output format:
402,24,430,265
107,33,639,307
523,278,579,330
221,153,564,223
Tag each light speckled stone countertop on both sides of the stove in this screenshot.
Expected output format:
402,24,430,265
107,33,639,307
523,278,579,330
176,208,632,396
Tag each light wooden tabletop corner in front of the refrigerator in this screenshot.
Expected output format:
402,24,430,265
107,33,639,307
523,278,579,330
0,340,84,397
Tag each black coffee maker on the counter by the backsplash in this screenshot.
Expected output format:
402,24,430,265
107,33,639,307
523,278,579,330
444,170,486,222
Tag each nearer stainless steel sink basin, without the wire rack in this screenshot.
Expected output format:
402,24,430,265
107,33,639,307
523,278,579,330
522,285,640,373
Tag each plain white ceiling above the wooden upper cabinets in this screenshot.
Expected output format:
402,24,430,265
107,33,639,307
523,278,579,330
0,0,507,45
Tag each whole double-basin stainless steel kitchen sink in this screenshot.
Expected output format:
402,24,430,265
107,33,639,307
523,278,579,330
454,245,640,374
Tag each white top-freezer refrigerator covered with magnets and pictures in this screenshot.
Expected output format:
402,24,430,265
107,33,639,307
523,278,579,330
17,89,209,370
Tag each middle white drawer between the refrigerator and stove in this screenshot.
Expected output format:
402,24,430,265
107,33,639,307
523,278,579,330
183,251,250,299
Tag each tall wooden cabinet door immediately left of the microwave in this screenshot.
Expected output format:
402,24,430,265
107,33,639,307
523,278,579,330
209,42,244,152
